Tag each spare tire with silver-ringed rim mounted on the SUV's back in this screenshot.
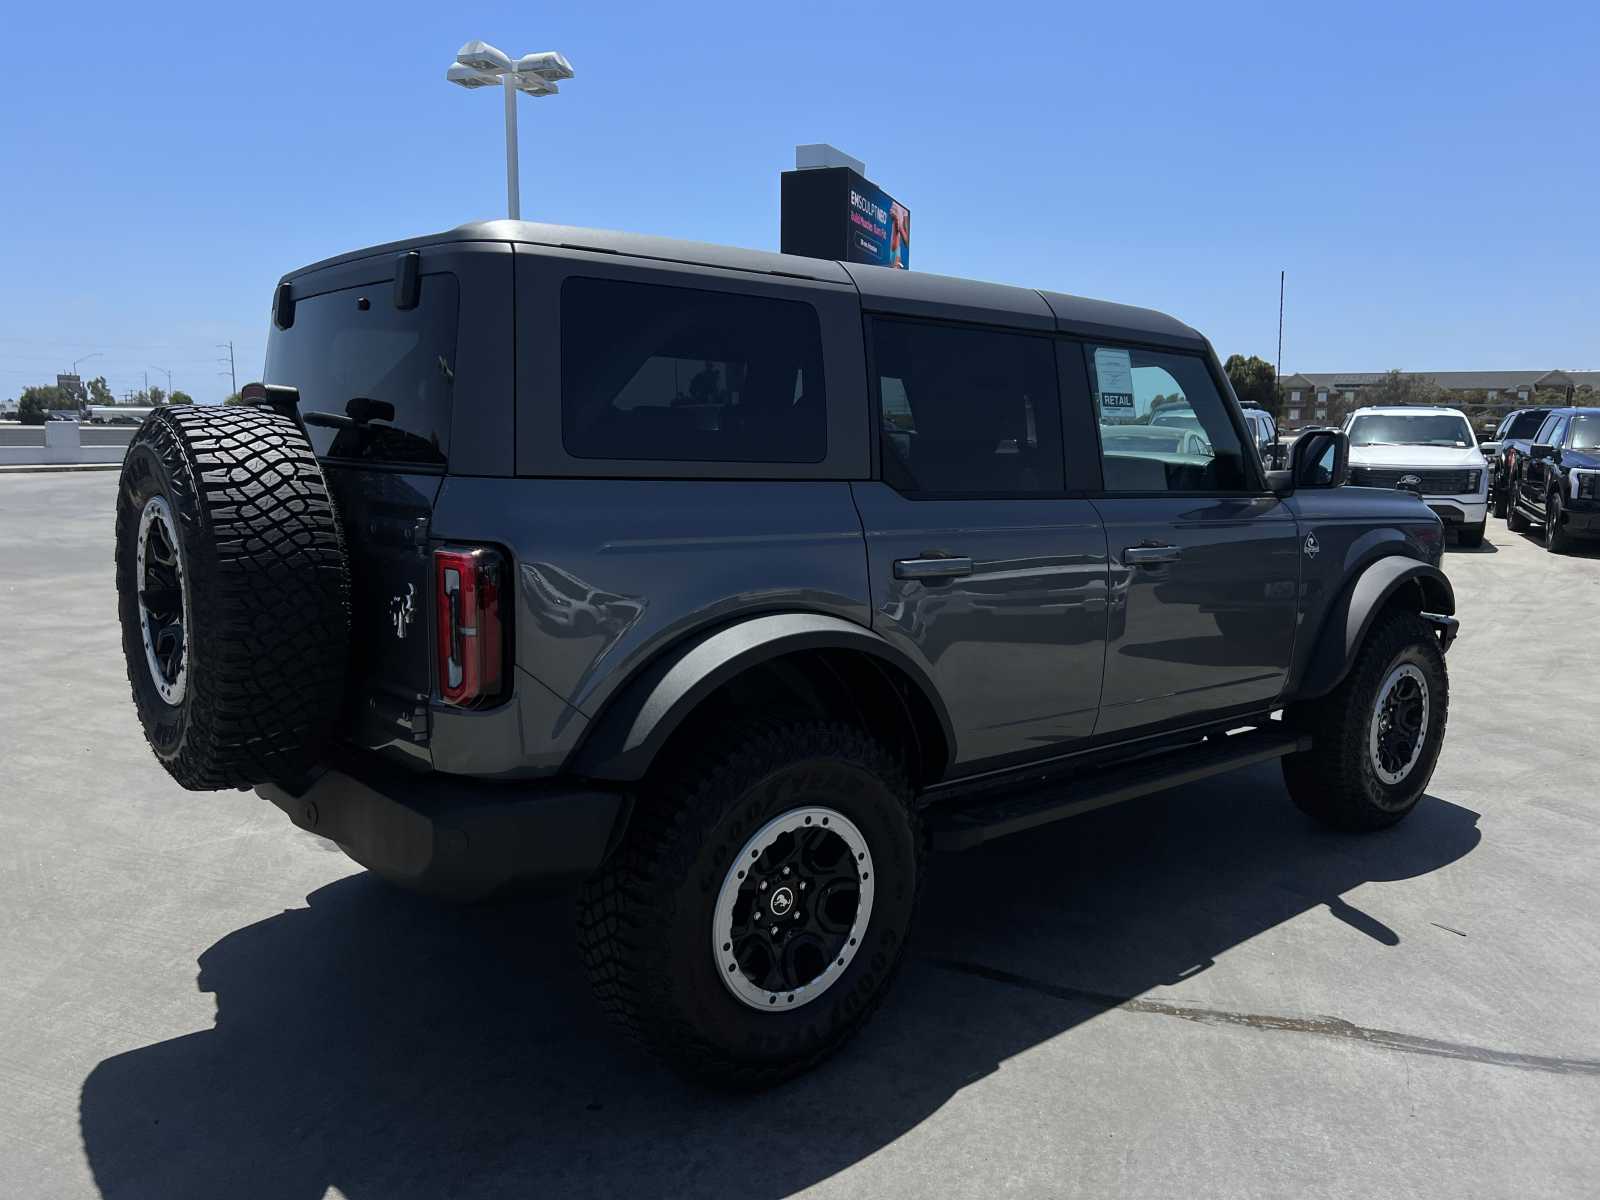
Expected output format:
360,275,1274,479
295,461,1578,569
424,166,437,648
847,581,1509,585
117,405,350,792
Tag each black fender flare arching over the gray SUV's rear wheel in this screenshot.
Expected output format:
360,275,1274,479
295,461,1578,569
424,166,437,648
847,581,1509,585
571,613,955,782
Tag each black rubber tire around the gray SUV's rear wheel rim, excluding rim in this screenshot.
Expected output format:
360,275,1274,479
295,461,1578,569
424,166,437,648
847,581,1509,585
578,720,923,1090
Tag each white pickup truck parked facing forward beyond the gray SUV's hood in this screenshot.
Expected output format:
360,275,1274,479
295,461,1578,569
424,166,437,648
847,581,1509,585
1344,405,1488,547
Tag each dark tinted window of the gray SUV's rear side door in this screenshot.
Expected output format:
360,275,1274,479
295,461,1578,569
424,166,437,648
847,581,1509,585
872,320,1062,496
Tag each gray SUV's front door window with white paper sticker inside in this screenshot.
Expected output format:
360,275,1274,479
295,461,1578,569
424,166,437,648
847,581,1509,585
1088,346,1248,491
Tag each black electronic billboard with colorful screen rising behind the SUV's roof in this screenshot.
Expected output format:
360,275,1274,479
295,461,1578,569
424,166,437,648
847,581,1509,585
781,166,910,270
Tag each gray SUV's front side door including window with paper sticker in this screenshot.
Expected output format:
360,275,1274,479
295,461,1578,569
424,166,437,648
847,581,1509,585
1083,342,1302,736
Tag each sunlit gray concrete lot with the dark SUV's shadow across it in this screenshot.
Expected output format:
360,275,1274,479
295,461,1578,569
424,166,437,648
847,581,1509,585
0,472,1600,1200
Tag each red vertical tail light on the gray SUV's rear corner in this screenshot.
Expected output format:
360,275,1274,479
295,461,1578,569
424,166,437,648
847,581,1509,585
434,546,506,709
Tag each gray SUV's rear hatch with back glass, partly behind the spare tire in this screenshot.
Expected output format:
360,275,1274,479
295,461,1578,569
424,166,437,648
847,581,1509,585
264,274,459,762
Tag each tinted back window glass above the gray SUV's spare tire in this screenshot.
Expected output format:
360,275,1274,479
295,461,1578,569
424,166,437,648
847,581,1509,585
262,275,459,467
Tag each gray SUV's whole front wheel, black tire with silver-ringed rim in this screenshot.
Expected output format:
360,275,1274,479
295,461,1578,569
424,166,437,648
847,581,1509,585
1283,611,1450,830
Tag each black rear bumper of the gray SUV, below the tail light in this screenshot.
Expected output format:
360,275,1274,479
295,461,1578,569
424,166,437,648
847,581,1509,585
256,755,627,899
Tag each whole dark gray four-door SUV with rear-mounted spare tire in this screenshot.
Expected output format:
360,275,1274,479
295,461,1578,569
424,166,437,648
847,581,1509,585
117,222,1456,1085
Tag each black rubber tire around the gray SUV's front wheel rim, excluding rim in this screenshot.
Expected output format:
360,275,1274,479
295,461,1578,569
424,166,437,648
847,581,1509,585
1283,610,1450,832
